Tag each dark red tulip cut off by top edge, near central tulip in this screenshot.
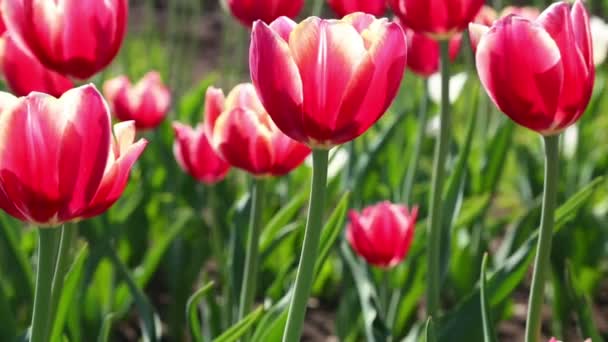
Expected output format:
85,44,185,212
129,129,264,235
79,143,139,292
228,0,304,27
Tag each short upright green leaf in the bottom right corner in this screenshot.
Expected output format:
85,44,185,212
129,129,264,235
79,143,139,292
566,261,603,341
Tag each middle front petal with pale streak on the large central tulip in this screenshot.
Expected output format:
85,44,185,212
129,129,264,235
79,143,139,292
289,17,366,143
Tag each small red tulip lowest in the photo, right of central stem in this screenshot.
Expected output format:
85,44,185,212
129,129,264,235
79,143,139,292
346,201,418,268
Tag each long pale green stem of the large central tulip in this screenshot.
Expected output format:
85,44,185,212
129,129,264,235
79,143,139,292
283,149,328,342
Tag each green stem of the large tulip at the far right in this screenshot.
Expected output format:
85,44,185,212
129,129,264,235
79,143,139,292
526,135,559,342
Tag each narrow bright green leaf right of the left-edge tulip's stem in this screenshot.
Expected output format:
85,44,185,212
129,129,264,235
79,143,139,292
51,247,89,342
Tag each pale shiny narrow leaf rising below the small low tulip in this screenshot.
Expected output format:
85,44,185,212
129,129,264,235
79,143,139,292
341,241,391,342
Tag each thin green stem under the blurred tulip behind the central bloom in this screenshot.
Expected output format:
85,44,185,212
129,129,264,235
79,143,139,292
239,178,265,320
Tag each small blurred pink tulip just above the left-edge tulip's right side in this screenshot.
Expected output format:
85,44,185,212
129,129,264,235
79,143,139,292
103,71,171,129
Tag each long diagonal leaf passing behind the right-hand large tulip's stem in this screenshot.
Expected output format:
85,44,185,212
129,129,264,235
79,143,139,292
439,177,604,341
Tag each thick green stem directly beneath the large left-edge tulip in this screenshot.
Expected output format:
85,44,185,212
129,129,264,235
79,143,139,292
30,228,62,342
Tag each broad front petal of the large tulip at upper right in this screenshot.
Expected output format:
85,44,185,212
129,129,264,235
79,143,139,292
476,16,564,131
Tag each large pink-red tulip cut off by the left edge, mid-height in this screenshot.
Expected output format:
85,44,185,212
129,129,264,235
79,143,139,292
0,85,146,226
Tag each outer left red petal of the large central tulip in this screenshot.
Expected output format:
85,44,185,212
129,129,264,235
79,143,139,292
249,22,308,142
